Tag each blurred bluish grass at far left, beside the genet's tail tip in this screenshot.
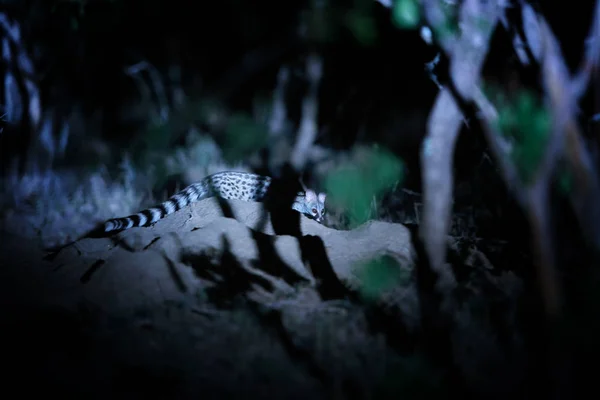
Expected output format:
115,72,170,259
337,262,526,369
0,158,150,247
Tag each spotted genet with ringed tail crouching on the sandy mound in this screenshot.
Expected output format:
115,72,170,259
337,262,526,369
104,172,325,232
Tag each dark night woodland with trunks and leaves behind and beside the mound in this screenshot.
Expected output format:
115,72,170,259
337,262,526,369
0,0,600,398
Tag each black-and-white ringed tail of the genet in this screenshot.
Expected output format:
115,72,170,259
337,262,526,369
104,180,212,232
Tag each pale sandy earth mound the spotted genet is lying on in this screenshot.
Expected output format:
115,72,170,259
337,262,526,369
0,201,435,399
